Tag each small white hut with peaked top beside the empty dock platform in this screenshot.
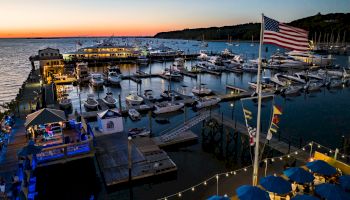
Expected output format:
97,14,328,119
97,109,124,134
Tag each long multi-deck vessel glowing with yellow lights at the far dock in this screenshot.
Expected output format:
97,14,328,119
63,43,140,61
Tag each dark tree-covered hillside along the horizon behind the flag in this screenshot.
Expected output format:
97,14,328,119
154,13,350,41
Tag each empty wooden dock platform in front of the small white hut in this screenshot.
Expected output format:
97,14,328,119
96,133,177,186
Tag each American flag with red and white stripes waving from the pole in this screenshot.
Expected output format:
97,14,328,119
263,16,309,51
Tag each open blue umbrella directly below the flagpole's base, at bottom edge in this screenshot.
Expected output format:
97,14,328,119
236,185,270,200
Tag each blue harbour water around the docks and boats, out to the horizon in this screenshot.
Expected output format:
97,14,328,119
0,38,350,199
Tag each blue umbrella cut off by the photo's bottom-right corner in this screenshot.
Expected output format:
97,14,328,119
315,183,350,200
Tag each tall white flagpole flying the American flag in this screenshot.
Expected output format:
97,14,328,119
253,14,265,186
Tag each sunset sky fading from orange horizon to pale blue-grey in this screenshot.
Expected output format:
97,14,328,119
0,0,350,38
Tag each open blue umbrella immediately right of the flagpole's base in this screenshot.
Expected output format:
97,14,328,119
260,176,292,194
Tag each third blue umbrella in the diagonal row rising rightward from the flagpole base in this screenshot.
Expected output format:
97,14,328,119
283,167,315,183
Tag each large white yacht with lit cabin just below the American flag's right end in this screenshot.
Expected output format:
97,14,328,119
287,50,333,66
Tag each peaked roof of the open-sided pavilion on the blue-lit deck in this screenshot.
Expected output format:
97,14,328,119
24,108,66,127
